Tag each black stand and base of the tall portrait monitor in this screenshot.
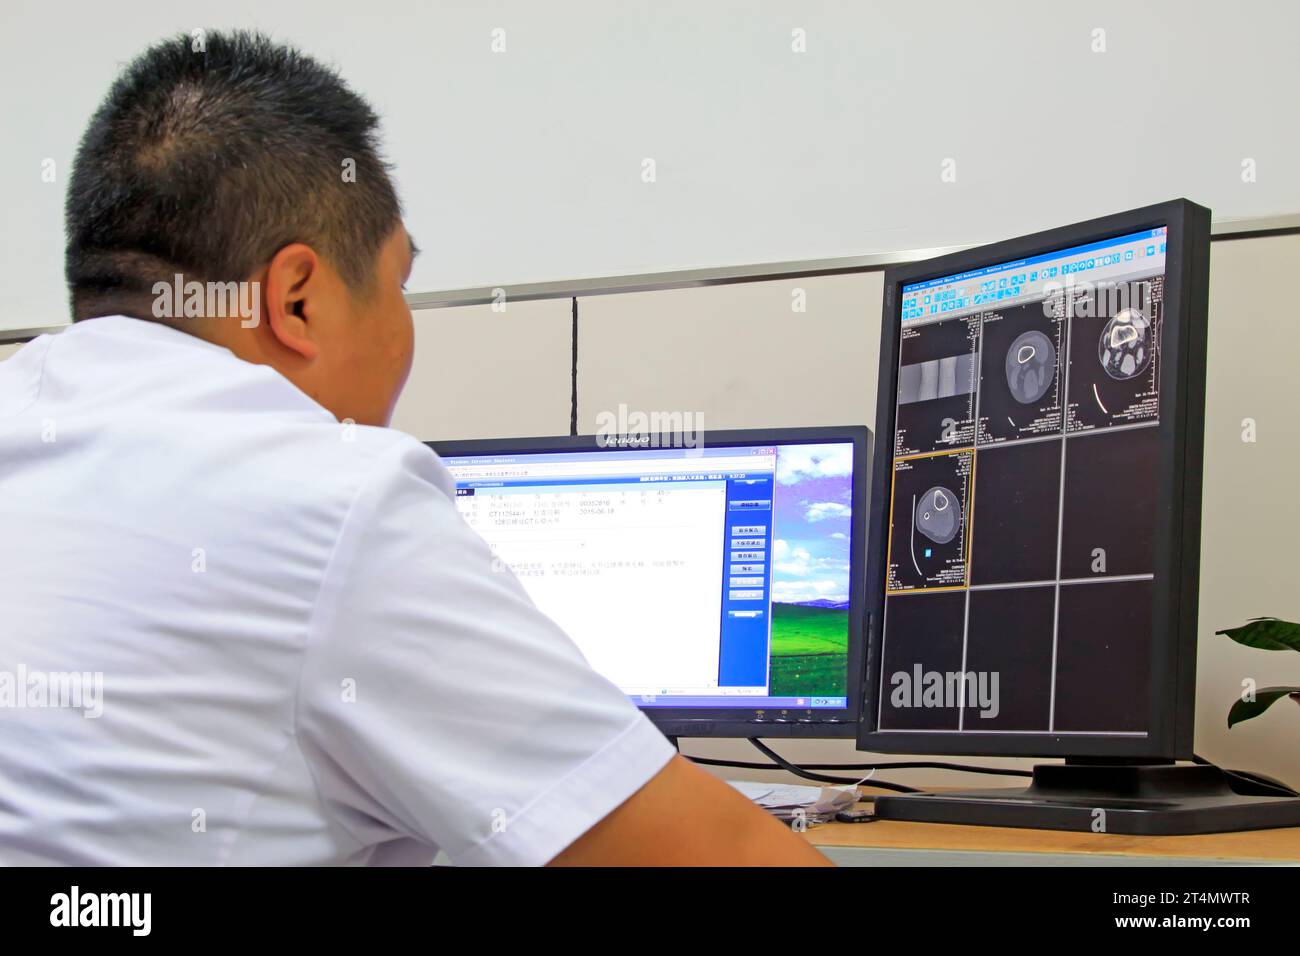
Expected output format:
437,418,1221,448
868,760,1300,834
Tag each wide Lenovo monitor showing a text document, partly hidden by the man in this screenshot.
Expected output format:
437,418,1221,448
429,427,870,737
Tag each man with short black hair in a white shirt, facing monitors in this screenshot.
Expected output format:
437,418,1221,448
0,34,826,865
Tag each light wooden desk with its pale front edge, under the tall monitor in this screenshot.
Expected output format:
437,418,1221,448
803,819,1300,866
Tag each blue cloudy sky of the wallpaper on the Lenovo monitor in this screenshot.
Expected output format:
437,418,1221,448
772,445,853,604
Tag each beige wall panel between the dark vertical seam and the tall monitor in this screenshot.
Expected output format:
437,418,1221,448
577,272,881,433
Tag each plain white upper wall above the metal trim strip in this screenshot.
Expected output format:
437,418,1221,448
0,0,1300,328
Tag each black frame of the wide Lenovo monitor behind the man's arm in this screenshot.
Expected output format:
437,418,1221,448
425,425,871,737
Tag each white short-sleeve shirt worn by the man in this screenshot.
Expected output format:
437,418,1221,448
0,316,672,865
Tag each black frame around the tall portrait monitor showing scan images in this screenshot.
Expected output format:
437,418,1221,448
858,199,1210,760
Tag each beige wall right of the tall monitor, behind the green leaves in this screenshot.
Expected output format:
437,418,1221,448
1196,235,1300,786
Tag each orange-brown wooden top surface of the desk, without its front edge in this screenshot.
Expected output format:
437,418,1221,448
805,819,1300,864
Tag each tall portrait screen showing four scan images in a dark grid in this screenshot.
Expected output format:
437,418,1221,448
868,200,1208,753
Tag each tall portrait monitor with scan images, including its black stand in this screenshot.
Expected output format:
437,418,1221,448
858,200,1294,832
